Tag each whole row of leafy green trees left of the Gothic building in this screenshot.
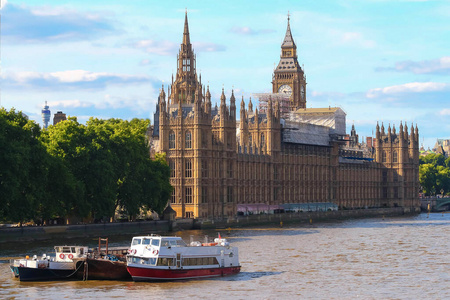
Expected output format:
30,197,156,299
0,109,172,222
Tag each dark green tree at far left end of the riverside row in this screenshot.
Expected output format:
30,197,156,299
0,108,47,222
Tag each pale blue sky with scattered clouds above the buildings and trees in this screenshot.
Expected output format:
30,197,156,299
0,0,450,148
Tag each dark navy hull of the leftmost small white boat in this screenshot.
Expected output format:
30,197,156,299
11,267,75,281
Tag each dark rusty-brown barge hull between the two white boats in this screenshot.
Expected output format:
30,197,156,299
76,258,131,280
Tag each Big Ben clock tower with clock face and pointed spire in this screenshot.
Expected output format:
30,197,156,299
272,15,306,110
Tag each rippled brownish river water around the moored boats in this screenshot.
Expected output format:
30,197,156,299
0,214,450,299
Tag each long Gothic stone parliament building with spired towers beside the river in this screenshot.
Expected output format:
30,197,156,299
150,14,420,219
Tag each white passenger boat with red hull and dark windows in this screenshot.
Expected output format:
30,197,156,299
127,235,241,281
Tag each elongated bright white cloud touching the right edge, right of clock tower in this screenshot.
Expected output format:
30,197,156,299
366,82,450,98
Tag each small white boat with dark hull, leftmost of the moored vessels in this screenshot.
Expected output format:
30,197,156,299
10,246,88,281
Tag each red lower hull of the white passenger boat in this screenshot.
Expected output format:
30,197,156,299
128,266,241,281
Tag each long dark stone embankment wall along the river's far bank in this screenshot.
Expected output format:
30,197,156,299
0,207,420,243
